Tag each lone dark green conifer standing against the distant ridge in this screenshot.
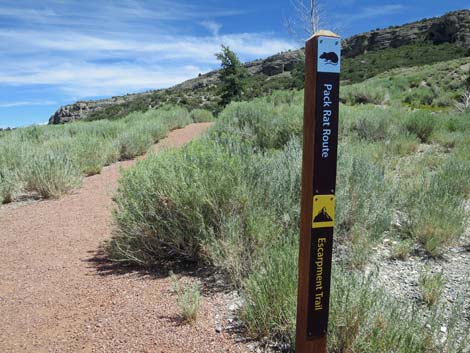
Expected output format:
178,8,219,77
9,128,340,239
215,45,248,106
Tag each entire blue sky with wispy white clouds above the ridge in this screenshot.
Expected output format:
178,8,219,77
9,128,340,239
0,0,469,127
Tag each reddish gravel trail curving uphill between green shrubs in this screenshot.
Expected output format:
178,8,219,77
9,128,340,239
0,124,247,353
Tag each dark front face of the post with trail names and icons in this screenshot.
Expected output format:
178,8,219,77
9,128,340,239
307,35,341,340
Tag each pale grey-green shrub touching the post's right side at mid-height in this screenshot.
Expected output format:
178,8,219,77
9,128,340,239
335,145,394,268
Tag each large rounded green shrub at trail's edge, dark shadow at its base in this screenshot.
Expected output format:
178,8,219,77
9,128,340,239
110,140,239,263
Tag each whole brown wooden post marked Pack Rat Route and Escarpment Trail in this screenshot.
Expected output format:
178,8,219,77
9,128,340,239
295,31,341,353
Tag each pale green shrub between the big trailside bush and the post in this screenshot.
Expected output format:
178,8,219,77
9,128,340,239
204,139,301,285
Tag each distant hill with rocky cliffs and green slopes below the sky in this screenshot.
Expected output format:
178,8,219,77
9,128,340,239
49,10,470,124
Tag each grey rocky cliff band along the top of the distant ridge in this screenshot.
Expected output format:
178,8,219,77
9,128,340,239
49,10,470,124
